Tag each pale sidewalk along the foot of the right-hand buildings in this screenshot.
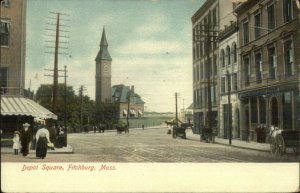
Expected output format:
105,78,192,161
187,130,270,152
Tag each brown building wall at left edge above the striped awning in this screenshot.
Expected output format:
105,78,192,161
0,0,26,96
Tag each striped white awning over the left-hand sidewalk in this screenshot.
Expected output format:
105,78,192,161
1,96,57,120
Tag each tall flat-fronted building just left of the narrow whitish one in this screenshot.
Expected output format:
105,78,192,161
191,0,235,133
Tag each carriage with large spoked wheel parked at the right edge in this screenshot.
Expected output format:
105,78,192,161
269,126,300,156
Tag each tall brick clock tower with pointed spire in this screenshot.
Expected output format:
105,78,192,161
95,27,112,104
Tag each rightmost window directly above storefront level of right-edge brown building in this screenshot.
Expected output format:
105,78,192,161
284,40,294,76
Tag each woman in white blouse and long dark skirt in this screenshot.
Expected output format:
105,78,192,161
35,120,51,159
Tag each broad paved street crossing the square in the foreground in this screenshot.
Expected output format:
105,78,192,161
1,128,297,163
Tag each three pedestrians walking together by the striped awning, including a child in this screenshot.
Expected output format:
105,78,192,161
13,120,52,159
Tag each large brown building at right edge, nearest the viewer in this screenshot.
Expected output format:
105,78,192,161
235,0,300,140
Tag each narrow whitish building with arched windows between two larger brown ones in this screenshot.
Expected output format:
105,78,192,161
218,21,240,139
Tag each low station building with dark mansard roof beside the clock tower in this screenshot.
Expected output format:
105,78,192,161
112,84,145,119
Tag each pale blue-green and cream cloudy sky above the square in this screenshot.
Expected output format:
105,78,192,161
26,0,205,112
